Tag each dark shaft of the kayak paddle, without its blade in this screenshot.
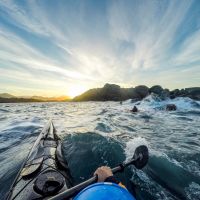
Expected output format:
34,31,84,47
49,158,138,200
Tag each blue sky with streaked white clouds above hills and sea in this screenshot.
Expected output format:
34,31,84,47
0,0,200,97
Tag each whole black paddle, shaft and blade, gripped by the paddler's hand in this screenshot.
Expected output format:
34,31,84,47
50,145,149,200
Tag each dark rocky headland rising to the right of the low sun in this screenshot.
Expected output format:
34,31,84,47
73,83,200,101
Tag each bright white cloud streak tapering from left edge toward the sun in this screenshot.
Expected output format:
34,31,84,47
0,25,93,79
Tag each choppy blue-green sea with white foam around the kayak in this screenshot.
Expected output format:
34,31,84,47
0,96,200,199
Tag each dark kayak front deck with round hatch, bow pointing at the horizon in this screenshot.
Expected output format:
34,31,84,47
7,120,73,200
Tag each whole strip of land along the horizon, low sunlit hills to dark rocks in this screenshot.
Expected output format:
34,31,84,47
0,83,200,103
